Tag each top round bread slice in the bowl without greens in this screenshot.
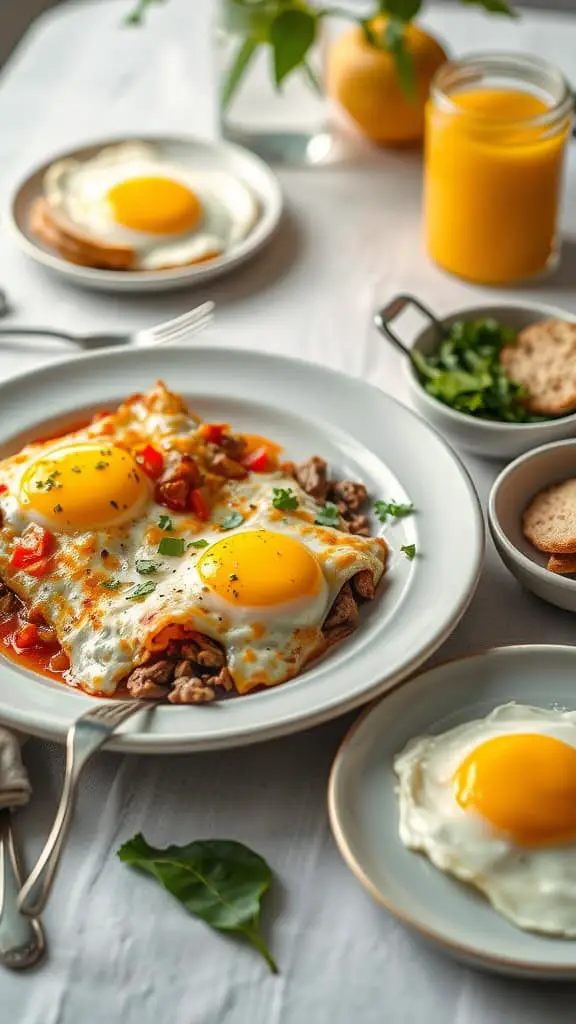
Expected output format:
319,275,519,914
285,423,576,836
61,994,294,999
522,478,576,555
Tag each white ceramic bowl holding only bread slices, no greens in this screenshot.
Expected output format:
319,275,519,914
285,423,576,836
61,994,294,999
488,438,576,611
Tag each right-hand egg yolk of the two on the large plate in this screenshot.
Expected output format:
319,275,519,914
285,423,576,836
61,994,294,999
198,529,323,607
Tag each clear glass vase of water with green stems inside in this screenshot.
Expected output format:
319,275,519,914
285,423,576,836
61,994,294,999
214,0,332,164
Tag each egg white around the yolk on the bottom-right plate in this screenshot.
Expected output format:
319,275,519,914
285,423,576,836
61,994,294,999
394,703,576,938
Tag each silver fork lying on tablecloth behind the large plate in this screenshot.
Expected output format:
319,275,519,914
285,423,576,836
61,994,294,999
0,302,214,349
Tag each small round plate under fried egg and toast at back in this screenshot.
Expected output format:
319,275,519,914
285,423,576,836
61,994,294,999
8,135,282,292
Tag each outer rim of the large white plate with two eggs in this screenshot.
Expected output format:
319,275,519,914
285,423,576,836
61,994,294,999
0,344,486,754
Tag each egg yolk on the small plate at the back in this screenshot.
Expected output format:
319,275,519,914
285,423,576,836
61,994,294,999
107,177,202,234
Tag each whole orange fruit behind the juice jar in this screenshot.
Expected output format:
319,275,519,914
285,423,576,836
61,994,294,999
327,17,448,145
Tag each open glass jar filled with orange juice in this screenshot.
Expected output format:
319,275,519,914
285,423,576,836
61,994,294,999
424,53,573,285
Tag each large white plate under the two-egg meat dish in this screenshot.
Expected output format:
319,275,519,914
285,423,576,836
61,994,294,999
0,347,484,753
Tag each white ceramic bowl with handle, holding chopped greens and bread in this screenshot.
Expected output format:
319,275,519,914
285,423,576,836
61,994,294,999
376,296,576,459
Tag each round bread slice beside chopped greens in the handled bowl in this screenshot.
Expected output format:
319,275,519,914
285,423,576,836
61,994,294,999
500,319,576,416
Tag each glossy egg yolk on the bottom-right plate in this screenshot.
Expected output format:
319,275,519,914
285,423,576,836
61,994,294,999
454,733,576,846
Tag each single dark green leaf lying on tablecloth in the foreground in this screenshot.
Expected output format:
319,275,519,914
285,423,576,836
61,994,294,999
118,833,278,974
